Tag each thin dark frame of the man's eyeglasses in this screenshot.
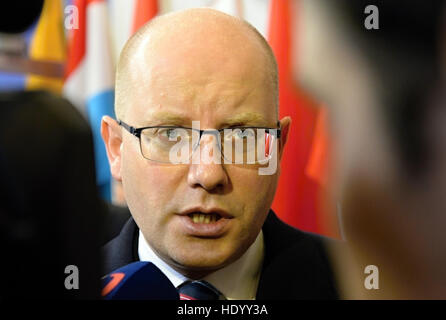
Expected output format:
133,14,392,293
116,120,282,163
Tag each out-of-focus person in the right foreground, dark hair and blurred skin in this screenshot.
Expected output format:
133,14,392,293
294,0,446,299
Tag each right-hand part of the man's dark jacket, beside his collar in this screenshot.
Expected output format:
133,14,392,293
256,210,338,300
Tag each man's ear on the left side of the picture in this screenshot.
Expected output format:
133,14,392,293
101,116,122,181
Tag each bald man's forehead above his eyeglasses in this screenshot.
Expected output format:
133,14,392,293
122,22,276,125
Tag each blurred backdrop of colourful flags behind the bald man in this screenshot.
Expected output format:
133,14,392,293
0,0,340,238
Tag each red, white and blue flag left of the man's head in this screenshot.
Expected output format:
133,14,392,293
64,0,114,200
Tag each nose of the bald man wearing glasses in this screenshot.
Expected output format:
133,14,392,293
187,135,229,192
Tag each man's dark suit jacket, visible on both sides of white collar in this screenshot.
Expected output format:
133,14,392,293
103,210,338,300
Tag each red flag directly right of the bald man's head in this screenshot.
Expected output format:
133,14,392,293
268,0,331,235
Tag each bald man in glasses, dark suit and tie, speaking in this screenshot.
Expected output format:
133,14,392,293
102,9,337,299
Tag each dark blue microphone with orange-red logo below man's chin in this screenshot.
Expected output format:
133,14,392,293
102,261,180,300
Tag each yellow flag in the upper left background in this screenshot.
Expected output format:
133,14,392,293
26,0,66,93
